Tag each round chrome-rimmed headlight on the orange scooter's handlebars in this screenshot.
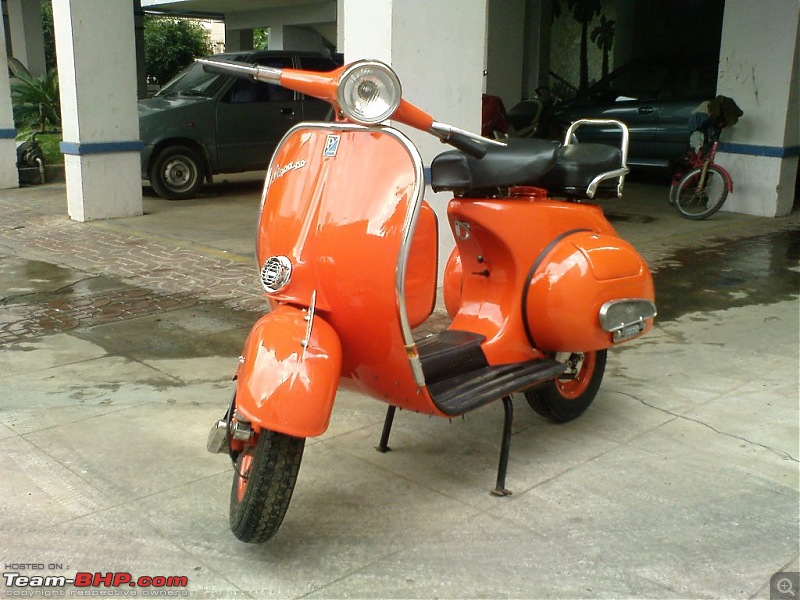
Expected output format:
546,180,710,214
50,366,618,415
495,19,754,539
336,60,403,125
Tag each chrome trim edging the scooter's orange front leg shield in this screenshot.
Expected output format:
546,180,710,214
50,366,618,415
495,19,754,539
256,121,425,387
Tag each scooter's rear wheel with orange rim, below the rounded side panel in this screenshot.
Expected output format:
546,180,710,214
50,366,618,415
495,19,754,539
525,350,608,423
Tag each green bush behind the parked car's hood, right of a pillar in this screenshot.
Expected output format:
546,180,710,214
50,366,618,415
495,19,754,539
144,15,211,85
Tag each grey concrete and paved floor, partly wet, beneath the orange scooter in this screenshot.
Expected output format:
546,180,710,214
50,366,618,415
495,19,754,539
0,178,800,598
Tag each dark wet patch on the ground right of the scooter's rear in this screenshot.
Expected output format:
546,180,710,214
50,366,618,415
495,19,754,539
654,229,800,321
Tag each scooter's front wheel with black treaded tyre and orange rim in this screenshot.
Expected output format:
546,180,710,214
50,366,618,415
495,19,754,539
230,429,306,543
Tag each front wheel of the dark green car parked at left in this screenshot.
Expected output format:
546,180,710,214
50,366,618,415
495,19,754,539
150,146,205,200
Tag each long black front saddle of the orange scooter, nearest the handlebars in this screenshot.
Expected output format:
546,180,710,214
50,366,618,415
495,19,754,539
431,138,559,194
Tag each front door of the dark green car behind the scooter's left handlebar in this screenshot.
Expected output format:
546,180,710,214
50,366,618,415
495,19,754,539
216,54,303,173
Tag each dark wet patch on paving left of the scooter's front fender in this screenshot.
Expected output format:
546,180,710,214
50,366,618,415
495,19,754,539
0,256,255,359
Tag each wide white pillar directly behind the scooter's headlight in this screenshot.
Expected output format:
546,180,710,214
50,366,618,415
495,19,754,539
338,0,487,274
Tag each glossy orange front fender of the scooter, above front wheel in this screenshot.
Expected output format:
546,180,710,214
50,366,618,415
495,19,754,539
236,305,342,438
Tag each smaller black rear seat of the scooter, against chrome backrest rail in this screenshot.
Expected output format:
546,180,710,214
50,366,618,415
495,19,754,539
538,144,622,196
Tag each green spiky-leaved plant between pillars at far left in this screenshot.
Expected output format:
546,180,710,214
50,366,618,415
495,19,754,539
11,69,61,130
